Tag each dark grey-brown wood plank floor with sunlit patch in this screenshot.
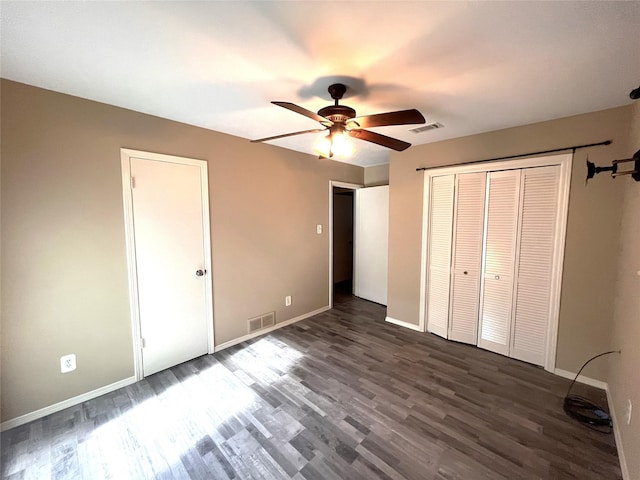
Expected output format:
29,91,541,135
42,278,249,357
1,294,621,480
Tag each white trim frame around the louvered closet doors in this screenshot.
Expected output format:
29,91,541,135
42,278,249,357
419,153,573,372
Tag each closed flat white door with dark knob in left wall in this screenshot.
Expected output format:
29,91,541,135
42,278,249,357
130,157,212,376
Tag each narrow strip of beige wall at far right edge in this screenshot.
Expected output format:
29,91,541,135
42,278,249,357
607,100,640,479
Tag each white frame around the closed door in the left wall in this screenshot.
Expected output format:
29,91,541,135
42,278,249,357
120,148,215,380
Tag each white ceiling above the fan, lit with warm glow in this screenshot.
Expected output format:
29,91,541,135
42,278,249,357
0,1,640,166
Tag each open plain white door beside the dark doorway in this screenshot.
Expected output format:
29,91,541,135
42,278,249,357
353,185,389,305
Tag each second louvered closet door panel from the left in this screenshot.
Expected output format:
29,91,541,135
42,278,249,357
449,172,487,345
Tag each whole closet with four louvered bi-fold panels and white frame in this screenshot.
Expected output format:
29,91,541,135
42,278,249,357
423,155,571,370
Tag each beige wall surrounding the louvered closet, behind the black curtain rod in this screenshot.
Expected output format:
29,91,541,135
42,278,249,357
387,107,631,380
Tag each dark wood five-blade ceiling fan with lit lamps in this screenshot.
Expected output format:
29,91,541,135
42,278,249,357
251,83,426,157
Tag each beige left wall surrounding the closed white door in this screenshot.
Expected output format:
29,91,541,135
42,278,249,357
1,80,364,421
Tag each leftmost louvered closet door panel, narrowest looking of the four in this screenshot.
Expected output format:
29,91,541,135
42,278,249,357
426,175,455,338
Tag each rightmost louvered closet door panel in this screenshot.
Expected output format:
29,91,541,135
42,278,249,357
510,165,560,365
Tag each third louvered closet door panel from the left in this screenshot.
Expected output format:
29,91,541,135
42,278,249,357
478,170,521,355
